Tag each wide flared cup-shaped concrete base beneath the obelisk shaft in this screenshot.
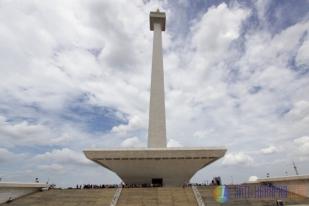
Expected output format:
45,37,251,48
84,148,226,186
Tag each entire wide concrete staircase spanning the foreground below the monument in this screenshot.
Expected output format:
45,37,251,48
1,186,309,206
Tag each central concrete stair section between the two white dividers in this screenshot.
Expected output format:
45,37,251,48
117,187,197,206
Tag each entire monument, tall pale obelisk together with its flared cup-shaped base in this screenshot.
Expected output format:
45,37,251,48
84,10,226,186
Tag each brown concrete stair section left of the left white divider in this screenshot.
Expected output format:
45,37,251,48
1,188,116,206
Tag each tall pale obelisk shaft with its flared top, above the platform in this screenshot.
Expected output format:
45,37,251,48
148,10,166,148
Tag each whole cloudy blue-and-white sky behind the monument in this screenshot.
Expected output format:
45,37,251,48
0,0,309,187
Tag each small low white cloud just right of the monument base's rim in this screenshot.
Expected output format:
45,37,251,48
222,152,253,166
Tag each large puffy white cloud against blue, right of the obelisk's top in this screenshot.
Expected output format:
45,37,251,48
193,3,250,66
